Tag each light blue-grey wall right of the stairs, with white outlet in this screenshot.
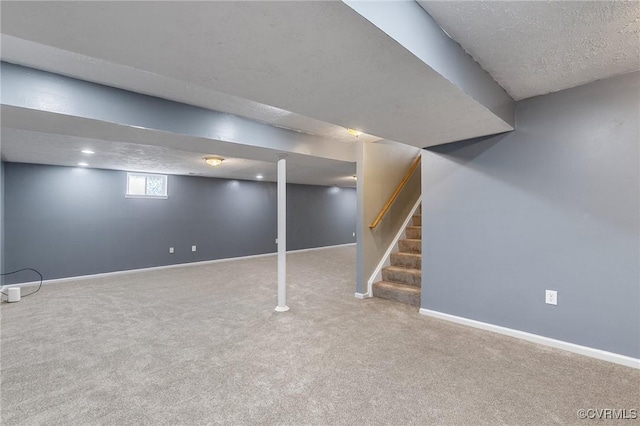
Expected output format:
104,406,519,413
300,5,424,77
422,72,640,358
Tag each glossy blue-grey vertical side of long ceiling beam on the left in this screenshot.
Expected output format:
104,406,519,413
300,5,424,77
0,62,355,162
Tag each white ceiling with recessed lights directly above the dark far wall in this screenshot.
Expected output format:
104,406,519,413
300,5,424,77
1,127,355,187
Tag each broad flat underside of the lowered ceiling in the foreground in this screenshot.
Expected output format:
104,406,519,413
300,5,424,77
1,1,511,147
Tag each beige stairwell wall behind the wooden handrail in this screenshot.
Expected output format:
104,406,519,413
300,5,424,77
356,140,421,294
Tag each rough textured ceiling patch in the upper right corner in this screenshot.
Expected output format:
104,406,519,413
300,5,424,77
419,1,640,100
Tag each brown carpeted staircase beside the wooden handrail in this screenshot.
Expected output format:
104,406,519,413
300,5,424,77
373,206,422,306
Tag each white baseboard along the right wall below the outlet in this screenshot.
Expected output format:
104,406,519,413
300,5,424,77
420,308,640,369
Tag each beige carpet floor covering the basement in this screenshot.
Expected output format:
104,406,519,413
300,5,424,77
1,247,640,426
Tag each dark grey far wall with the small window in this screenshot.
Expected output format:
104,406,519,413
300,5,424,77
4,163,356,284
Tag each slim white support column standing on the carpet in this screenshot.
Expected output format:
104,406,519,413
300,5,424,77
276,157,289,312
